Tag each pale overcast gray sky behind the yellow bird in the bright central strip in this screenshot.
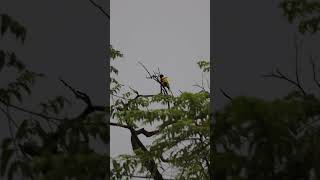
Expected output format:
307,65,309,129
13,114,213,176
110,0,210,160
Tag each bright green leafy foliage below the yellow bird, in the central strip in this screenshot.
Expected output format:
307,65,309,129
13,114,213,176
111,47,210,179
